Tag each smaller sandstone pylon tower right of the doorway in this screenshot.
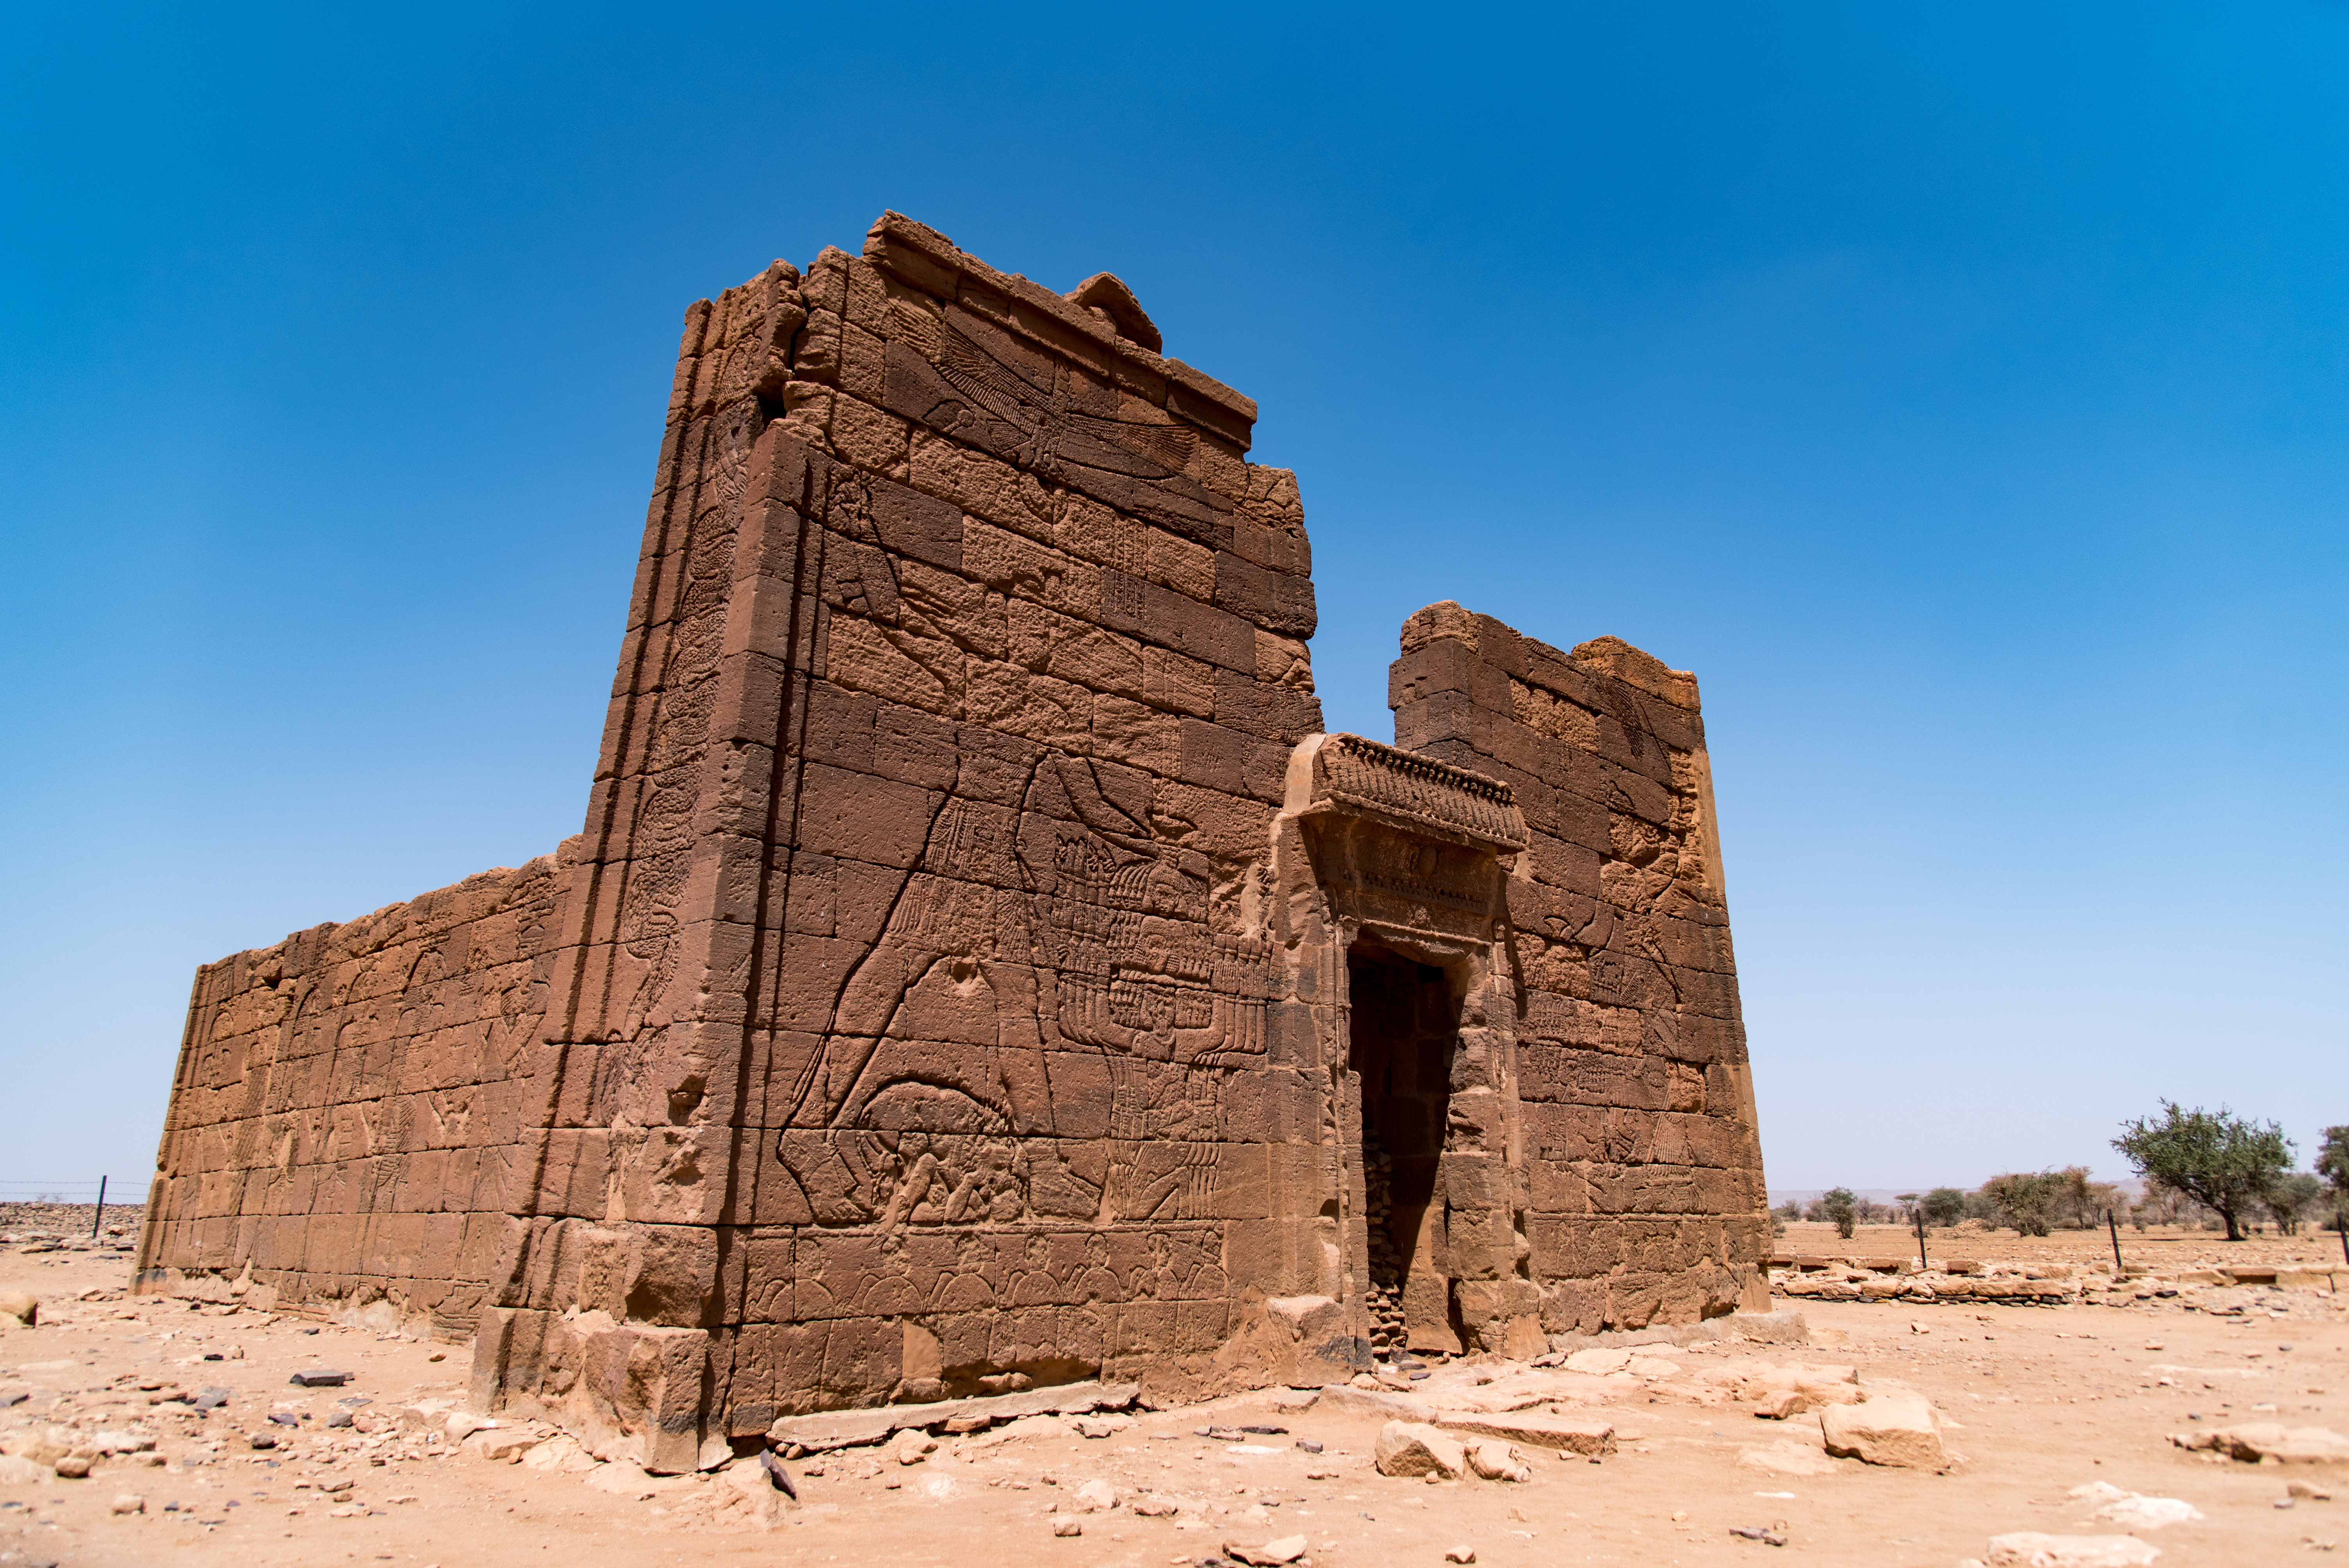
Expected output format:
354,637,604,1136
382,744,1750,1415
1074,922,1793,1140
1388,603,1771,1331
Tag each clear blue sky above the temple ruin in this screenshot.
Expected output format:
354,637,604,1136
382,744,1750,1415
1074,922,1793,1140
0,5,2349,1192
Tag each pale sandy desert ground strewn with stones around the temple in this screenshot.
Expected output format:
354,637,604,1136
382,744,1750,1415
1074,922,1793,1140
0,1225,2349,1568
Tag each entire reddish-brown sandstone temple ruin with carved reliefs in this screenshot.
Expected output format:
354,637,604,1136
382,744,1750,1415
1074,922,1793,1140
139,214,1769,1469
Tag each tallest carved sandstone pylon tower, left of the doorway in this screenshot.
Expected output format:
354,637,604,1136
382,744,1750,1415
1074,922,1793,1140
467,218,1325,1432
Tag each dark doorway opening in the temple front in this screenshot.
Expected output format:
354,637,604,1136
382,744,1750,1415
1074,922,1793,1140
1346,939,1461,1352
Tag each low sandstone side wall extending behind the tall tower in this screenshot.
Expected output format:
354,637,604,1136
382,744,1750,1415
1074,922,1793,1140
139,857,559,1336
